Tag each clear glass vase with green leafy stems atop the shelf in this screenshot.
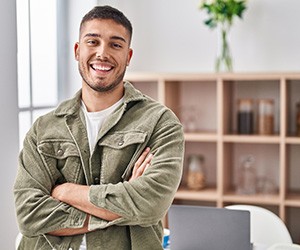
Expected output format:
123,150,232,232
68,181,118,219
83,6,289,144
200,0,246,72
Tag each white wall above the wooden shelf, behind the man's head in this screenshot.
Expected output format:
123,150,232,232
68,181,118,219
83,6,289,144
64,0,300,87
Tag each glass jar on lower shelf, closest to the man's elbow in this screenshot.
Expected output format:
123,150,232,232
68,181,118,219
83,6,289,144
186,155,205,190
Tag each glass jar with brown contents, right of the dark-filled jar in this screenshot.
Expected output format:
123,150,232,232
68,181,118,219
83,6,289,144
257,99,274,135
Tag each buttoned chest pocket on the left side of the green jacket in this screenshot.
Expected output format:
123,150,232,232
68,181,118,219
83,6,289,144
38,140,83,184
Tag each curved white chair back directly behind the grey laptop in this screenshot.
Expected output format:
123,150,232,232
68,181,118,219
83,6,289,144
226,205,293,249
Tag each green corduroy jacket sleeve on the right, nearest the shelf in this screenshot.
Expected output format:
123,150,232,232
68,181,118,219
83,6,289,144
89,112,184,230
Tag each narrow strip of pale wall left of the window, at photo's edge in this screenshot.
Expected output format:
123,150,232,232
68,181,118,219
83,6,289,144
0,0,19,250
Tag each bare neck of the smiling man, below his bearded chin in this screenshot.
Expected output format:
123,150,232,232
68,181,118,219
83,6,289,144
82,84,124,112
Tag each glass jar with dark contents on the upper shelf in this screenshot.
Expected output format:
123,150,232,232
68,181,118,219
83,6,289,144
237,99,254,135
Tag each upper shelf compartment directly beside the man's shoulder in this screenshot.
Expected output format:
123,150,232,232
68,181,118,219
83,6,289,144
165,80,217,133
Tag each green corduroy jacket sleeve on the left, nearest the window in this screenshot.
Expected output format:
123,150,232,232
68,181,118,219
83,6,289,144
14,122,86,237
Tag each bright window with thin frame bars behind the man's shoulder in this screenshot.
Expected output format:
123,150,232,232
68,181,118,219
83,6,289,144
16,0,58,145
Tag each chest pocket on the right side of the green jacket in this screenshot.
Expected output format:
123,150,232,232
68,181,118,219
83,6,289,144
98,131,147,184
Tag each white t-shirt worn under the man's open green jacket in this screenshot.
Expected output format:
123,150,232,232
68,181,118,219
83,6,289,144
79,98,123,250
